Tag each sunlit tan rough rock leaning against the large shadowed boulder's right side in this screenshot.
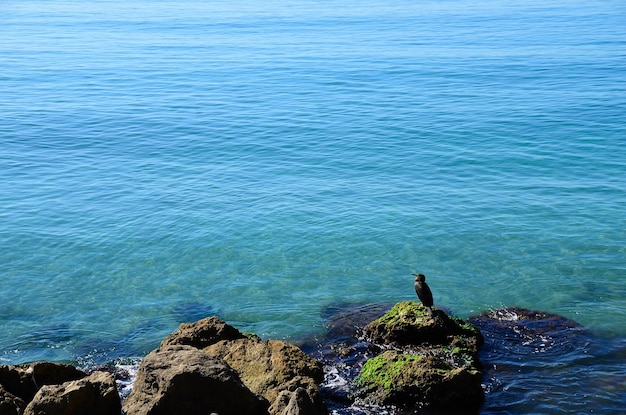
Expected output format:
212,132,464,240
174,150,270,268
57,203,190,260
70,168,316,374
204,338,327,415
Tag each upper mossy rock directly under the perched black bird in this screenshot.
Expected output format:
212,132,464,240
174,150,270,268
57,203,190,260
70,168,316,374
364,301,483,354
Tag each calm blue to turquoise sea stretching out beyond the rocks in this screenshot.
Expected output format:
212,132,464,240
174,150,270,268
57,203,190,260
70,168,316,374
0,0,626,412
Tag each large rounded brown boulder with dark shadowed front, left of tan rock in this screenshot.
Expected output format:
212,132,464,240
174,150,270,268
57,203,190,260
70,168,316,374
123,345,268,415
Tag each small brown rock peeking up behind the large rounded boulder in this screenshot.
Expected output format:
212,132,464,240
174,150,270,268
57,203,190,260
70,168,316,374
161,317,246,349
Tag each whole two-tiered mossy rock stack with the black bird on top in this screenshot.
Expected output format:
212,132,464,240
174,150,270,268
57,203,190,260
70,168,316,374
355,302,484,410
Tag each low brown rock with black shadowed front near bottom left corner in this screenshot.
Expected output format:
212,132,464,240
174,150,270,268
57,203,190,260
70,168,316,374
24,372,121,415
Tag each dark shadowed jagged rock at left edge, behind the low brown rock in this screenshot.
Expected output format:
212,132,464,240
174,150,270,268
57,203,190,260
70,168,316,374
0,362,87,402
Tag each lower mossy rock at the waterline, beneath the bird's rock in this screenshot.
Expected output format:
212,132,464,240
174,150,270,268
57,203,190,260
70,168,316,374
356,350,484,409
